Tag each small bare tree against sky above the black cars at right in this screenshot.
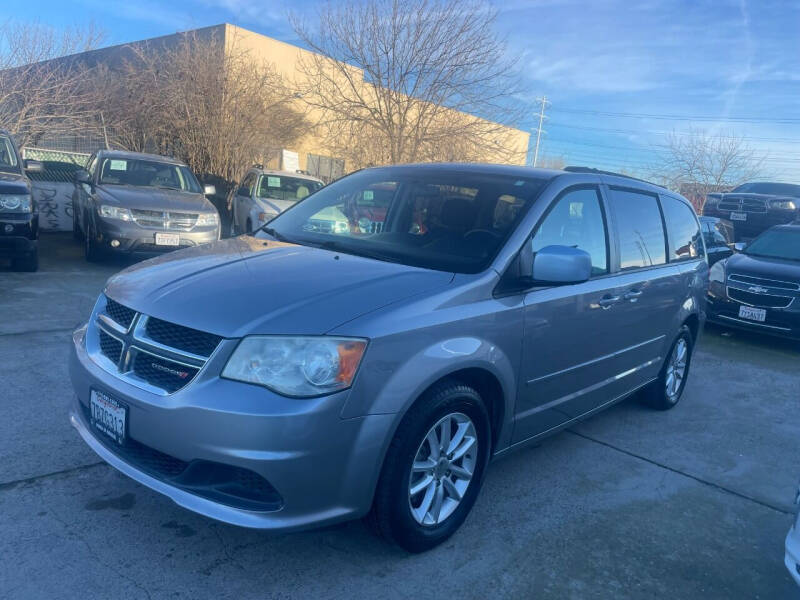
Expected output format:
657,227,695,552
651,129,766,208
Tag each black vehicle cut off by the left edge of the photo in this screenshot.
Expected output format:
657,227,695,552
0,130,42,271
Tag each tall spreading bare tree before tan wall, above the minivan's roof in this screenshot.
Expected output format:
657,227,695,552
293,0,524,167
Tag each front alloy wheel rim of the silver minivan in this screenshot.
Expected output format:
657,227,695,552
408,412,478,526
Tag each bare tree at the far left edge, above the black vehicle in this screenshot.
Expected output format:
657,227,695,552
0,21,102,145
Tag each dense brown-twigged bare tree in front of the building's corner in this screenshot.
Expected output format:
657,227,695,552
102,33,305,181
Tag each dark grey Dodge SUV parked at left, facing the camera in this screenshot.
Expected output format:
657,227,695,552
72,150,220,261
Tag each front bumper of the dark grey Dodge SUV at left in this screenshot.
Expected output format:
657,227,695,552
95,219,220,255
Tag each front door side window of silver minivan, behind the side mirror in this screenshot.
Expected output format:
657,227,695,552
532,188,608,275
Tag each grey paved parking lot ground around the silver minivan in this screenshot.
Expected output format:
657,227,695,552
0,234,800,599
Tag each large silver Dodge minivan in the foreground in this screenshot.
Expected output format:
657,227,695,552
70,164,708,552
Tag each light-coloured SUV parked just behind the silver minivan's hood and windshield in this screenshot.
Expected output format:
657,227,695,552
230,166,324,235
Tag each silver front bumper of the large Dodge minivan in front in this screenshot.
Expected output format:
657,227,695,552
70,330,394,530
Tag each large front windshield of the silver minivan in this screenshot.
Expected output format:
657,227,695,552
260,167,546,273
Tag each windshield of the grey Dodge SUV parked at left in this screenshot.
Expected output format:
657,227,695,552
100,158,201,194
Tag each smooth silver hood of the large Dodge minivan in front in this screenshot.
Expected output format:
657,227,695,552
105,236,453,337
